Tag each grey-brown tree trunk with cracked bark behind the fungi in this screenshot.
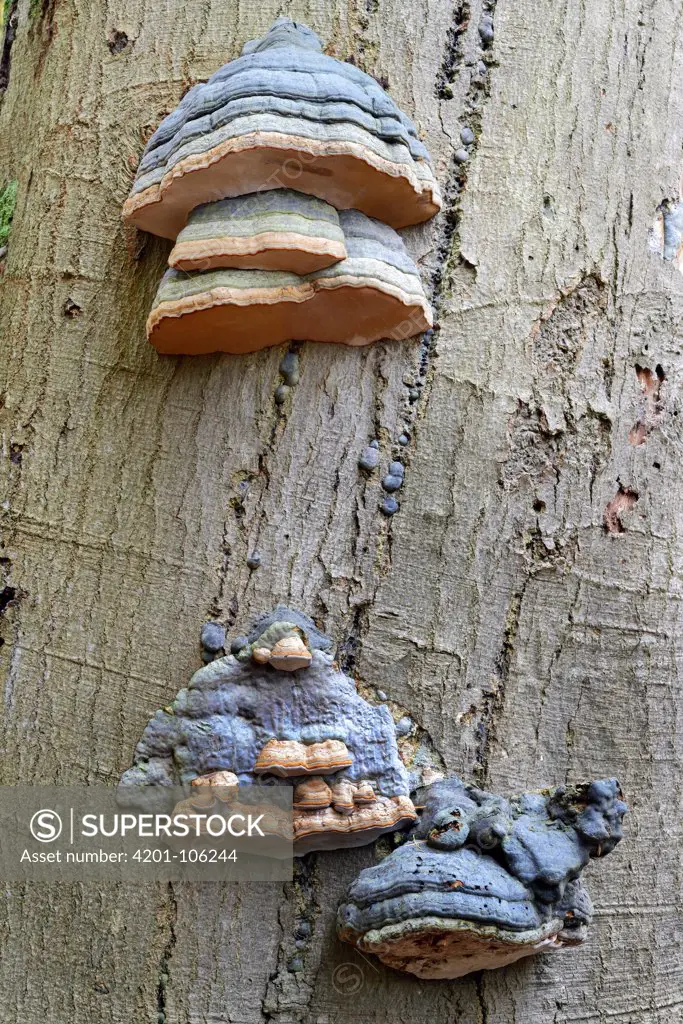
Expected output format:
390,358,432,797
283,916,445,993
0,0,683,1024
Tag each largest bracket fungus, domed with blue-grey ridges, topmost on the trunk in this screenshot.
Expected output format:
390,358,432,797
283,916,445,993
124,17,441,239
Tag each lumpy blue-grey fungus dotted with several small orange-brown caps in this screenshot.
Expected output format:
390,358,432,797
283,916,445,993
119,606,417,855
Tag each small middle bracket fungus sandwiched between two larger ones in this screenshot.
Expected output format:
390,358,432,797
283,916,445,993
168,188,346,274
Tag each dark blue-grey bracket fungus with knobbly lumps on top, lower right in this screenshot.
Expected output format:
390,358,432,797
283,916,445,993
337,778,627,979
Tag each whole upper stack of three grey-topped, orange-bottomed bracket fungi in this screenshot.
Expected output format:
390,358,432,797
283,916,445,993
124,18,441,354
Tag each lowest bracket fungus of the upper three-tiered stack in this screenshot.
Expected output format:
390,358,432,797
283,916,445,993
147,210,433,354
